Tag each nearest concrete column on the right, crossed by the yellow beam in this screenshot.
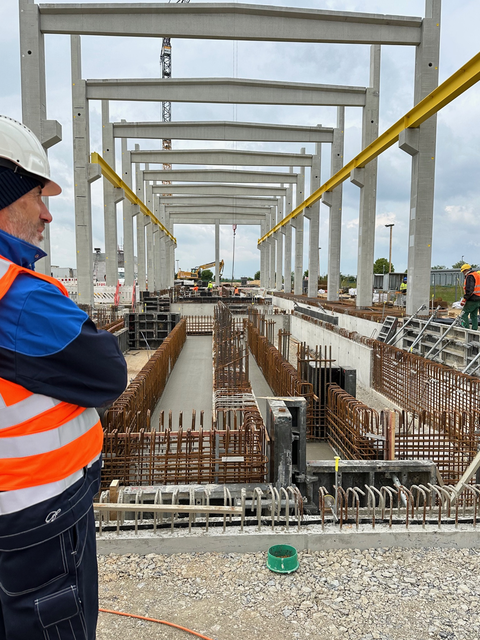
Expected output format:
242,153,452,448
406,0,441,315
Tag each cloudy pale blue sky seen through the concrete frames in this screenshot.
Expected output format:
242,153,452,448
0,0,480,277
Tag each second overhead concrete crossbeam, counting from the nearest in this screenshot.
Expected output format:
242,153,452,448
87,78,366,107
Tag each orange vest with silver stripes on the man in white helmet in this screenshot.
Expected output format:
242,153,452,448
0,256,103,498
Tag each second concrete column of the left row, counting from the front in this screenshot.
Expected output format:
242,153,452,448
70,36,93,305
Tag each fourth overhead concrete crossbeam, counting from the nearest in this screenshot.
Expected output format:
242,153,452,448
131,149,313,167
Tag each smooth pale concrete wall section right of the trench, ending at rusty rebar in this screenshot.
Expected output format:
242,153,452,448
290,316,373,387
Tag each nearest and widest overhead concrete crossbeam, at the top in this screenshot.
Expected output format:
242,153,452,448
39,3,422,45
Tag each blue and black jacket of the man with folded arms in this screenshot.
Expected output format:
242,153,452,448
0,230,127,407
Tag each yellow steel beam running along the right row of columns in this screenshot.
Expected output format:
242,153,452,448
258,53,480,244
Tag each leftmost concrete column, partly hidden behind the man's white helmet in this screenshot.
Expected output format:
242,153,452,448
19,0,62,275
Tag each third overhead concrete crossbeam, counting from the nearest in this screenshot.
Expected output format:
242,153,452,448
113,121,333,143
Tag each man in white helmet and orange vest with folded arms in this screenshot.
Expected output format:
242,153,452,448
0,116,127,640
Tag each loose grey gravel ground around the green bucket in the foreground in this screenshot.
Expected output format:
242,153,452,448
97,549,480,640
